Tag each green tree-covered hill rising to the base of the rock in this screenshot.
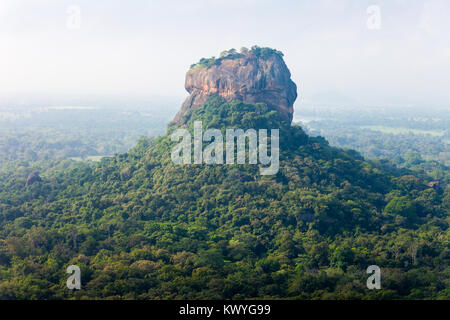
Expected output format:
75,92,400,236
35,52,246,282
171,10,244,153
0,96,450,299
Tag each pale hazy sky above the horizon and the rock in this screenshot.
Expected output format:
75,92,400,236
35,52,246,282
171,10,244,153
0,0,450,107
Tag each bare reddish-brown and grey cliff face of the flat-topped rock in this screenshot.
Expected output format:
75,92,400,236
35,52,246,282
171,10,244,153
174,51,297,124
